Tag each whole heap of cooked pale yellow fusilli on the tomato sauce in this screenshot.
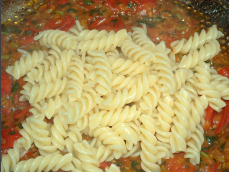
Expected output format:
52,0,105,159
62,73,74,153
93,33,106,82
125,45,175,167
1,21,229,172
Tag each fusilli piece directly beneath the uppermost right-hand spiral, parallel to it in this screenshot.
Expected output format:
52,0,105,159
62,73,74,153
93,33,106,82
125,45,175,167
178,40,220,69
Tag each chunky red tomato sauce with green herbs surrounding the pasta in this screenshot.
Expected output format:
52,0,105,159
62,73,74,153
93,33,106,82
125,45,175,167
1,0,229,172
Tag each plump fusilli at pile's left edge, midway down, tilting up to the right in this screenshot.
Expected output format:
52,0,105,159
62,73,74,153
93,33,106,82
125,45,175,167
20,77,67,104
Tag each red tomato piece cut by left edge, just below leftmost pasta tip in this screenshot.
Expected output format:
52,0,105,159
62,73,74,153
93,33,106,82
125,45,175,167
1,72,12,95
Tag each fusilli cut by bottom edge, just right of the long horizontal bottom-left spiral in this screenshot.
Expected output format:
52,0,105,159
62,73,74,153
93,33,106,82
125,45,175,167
74,140,103,172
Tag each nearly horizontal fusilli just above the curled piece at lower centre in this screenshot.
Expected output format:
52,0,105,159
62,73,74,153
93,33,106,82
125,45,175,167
89,105,140,130
